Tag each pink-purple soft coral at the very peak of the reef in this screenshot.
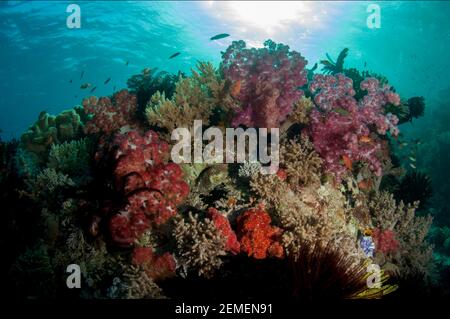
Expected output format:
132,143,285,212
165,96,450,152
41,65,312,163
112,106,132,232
222,40,307,128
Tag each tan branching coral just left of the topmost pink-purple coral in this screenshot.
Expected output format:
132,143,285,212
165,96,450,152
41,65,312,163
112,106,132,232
145,63,234,134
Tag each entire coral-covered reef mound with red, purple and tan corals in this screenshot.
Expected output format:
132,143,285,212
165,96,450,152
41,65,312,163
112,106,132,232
0,40,432,298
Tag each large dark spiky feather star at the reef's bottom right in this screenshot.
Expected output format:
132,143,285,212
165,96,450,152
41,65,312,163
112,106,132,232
290,242,396,299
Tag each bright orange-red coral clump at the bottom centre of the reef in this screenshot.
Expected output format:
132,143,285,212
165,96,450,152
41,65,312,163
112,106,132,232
237,208,284,259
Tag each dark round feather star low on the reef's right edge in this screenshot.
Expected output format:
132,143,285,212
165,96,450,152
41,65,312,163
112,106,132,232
395,171,433,209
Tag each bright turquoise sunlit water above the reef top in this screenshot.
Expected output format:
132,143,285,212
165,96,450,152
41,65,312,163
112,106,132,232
0,1,450,139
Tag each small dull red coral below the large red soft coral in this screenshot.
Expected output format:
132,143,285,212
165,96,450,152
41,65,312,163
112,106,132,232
132,247,176,280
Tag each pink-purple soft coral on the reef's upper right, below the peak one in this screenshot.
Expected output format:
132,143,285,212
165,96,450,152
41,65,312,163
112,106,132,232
310,74,400,179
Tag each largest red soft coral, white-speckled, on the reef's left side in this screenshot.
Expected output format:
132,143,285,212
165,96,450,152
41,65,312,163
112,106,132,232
104,131,189,246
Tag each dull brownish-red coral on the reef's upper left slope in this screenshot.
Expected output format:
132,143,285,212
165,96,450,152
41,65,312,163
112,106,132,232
83,90,137,134
